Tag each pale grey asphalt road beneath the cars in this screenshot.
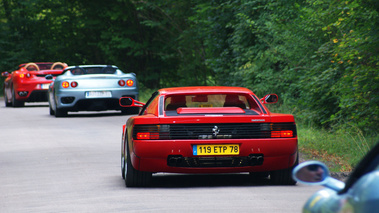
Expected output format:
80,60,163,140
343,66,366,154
0,99,320,213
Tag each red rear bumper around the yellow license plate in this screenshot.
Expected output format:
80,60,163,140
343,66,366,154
129,138,297,173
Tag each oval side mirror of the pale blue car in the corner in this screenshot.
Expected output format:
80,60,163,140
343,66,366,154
292,161,345,191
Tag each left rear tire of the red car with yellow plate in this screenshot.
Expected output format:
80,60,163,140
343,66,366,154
124,149,153,187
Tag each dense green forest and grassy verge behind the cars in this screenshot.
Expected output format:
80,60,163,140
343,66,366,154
0,0,379,170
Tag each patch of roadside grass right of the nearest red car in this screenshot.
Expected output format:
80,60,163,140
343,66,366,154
297,124,378,172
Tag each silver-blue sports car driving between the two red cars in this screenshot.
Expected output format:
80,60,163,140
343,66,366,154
46,65,139,117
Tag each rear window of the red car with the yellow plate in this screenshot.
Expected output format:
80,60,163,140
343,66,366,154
164,94,260,111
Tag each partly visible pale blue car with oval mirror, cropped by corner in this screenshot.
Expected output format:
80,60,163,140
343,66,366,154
293,142,379,213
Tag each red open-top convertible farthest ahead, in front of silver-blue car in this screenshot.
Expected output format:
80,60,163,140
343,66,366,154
1,62,67,107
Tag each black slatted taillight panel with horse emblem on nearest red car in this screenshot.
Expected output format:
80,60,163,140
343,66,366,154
133,123,297,140
